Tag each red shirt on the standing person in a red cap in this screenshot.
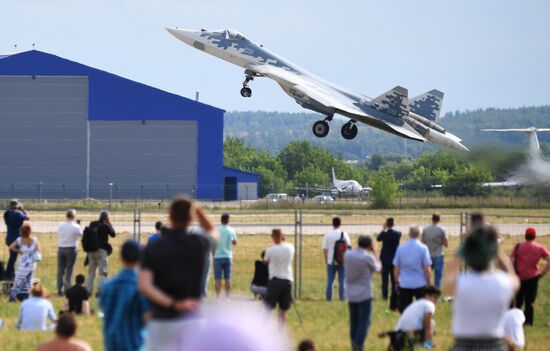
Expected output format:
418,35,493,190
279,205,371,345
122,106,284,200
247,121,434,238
512,241,550,280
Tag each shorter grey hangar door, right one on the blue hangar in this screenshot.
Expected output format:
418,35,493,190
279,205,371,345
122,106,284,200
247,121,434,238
90,120,197,199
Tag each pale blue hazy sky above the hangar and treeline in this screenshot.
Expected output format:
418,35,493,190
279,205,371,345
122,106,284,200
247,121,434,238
0,0,550,113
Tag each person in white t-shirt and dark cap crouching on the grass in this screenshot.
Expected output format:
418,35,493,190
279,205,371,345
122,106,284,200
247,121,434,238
395,286,441,349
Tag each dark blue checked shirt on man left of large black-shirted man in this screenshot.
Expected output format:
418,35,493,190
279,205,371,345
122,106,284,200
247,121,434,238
100,268,148,351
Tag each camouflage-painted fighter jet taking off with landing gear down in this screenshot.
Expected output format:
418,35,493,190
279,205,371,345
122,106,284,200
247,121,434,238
166,28,468,151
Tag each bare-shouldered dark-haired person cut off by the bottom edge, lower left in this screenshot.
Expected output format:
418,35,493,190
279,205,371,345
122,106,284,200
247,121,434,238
36,313,92,351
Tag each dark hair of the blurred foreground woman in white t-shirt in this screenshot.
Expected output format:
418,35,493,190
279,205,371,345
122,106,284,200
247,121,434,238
459,226,498,272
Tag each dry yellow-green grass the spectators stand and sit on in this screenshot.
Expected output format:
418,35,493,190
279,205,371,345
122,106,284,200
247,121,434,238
0,235,550,351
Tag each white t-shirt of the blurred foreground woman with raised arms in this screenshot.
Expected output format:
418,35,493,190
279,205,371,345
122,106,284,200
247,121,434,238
452,271,514,339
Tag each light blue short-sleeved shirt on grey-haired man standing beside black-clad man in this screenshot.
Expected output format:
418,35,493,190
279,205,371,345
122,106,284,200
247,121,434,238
393,239,432,289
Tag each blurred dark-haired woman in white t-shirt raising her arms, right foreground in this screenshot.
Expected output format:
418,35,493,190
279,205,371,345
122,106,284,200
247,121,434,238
445,225,519,351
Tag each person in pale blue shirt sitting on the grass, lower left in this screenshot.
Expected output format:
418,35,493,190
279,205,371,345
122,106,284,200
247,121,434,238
16,283,57,331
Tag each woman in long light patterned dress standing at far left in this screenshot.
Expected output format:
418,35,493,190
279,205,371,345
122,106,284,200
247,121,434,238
10,224,40,302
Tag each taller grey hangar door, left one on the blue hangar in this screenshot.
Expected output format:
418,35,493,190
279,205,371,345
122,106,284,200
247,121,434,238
0,76,88,198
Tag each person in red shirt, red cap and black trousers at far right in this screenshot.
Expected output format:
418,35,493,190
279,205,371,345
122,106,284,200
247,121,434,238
511,227,550,325
